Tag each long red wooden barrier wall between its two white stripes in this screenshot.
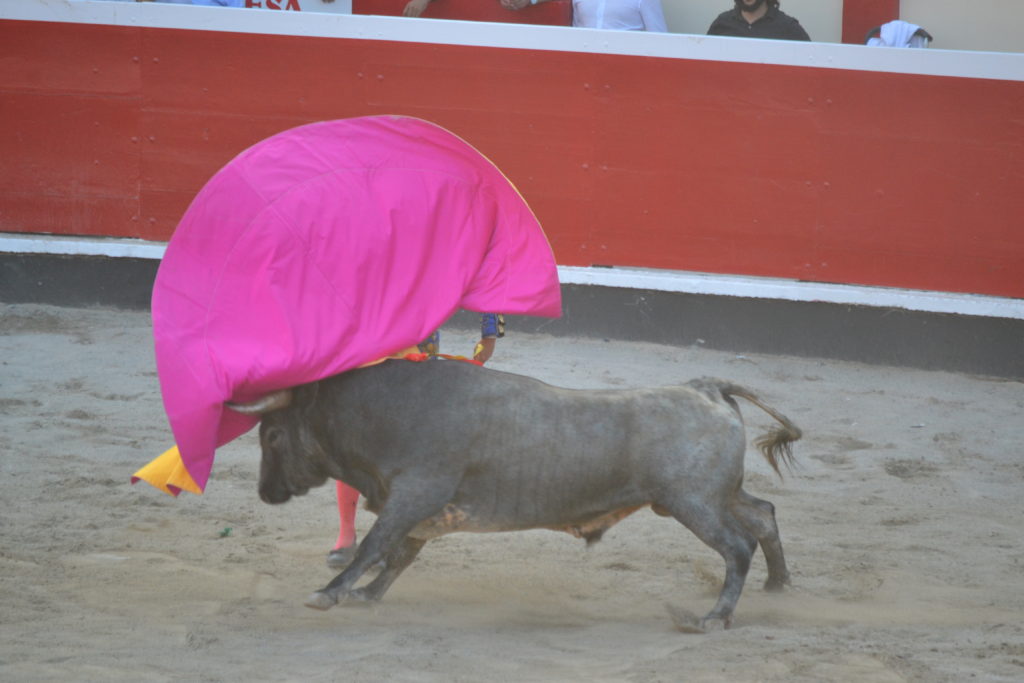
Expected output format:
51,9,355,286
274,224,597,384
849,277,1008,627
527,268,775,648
0,15,1024,297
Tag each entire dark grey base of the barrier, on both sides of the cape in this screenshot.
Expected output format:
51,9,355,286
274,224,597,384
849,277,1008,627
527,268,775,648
0,254,1024,379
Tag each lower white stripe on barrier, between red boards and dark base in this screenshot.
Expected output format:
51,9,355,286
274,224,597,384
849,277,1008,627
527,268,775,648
0,234,1024,319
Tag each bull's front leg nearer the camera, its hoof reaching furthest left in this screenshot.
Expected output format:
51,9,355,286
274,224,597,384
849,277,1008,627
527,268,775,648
305,477,458,609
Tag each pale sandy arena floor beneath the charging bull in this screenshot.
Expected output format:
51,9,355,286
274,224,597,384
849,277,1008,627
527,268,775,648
0,305,1024,683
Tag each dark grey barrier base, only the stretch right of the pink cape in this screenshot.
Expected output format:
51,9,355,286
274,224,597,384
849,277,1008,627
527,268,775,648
453,285,1024,379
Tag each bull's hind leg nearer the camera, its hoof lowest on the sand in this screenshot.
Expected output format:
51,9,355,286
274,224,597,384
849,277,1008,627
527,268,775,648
660,498,758,630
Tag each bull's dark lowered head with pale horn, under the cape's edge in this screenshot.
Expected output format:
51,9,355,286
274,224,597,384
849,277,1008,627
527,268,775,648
227,383,328,504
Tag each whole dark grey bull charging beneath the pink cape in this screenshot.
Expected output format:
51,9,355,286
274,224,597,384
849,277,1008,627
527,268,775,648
230,360,801,628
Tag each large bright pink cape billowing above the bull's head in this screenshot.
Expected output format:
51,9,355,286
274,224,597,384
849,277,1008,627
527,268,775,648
137,117,561,494
